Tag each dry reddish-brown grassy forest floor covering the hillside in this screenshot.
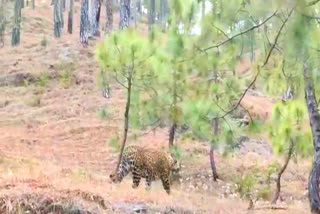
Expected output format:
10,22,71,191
0,0,311,214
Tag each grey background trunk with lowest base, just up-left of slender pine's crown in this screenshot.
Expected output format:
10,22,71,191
80,0,89,45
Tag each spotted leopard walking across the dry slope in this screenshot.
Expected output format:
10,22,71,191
109,145,181,195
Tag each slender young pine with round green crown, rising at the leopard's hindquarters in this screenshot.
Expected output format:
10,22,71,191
97,30,152,176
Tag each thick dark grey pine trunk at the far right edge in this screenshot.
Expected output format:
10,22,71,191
304,64,320,213
